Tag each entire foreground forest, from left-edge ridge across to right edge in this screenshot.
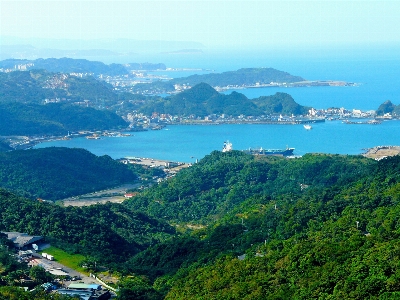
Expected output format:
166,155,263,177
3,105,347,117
0,151,400,299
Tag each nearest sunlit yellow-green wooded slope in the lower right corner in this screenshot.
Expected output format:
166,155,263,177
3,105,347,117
158,157,400,299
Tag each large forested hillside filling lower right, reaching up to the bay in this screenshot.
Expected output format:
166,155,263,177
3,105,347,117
118,151,400,299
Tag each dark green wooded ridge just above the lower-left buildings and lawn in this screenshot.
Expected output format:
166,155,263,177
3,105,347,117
0,189,175,264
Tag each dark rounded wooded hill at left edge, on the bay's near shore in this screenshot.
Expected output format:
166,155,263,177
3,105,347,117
0,147,137,200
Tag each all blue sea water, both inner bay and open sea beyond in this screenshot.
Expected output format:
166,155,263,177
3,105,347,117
32,51,400,162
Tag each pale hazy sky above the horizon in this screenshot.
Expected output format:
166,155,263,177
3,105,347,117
0,0,400,47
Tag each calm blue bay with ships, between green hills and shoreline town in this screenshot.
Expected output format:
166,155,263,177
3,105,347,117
35,120,400,163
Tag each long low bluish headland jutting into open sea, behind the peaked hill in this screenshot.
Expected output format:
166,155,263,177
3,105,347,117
134,68,305,92
